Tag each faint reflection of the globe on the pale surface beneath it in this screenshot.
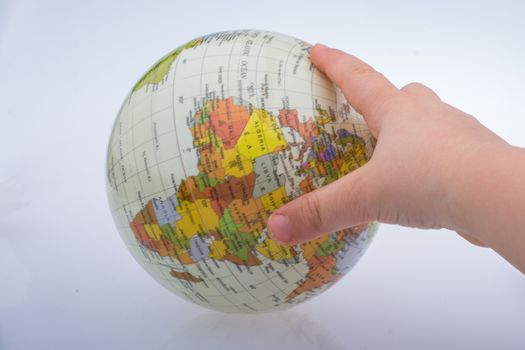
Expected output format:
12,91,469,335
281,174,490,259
160,311,347,350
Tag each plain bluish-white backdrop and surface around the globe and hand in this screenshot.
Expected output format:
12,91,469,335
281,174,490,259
0,0,525,349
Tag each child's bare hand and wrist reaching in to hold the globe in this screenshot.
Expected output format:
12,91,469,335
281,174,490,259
268,44,525,273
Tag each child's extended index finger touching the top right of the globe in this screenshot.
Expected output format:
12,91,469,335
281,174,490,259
311,44,400,136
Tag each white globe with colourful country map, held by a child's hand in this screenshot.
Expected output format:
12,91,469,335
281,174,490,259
107,30,377,313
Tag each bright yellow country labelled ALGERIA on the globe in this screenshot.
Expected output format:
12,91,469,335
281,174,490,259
235,109,286,159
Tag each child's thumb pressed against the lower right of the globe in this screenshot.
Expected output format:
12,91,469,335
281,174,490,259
268,164,374,245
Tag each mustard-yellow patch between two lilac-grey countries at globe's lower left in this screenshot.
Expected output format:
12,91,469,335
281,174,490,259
175,199,219,239
